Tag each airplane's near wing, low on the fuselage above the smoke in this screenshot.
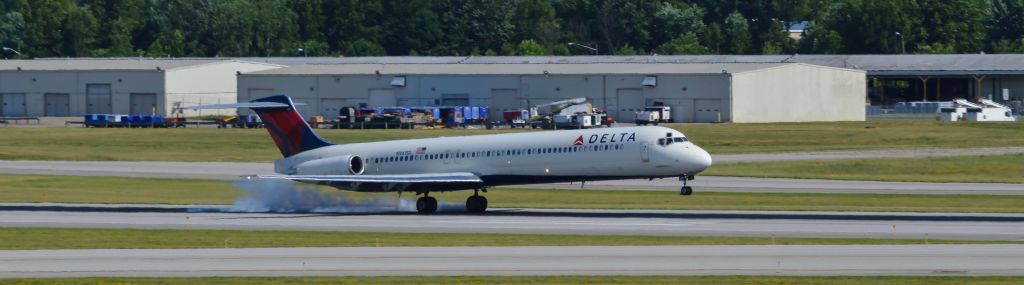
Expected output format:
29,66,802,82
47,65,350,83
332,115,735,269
250,172,483,192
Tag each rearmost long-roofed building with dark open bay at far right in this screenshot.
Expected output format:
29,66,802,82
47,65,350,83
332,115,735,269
247,54,1024,107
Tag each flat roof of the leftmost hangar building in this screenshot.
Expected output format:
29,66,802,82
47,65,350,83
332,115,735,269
0,58,280,71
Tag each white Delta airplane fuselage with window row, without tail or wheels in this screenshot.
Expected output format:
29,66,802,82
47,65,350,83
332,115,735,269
274,126,712,191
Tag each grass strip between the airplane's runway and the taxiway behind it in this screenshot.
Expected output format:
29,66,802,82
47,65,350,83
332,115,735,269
0,174,1024,212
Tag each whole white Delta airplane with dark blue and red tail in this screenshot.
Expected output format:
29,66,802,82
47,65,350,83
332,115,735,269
195,95,712,213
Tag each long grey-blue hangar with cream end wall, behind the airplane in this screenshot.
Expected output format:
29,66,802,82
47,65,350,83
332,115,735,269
238,62,867,122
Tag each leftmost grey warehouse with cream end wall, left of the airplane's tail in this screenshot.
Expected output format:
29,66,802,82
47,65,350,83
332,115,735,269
0,58,282,117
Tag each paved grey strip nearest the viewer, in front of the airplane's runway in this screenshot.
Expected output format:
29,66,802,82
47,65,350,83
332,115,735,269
0,245,1024,278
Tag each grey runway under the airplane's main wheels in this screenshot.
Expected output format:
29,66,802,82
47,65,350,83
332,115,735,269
0,204,1024,241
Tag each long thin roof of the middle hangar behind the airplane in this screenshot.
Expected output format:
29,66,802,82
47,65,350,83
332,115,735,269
248,63,798,75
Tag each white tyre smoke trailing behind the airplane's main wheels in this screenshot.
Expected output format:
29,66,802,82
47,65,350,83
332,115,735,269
228,178,466,213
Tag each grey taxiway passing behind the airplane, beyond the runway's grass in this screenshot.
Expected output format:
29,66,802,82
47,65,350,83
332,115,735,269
0,158,1024,195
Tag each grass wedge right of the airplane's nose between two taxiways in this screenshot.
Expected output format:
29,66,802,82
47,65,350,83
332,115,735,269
705,154,1024,184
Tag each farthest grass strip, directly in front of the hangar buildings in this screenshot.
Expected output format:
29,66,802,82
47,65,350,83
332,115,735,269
0,120,1024,161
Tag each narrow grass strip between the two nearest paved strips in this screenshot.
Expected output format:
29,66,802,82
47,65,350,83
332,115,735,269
0,228,1007,250
